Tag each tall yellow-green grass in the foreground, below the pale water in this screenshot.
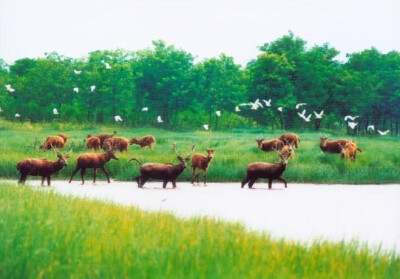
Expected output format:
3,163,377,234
0,183,400,278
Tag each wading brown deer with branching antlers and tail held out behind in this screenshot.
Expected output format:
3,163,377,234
129,143,196,188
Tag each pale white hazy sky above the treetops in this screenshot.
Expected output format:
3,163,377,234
0,0,400,65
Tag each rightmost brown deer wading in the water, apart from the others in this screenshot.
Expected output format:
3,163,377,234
242,153,290,189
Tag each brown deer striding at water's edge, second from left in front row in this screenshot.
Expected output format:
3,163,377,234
69,143,118,185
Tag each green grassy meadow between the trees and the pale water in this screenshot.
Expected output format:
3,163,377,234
0,121,400,184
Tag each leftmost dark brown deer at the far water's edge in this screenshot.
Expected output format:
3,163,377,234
17,147,70,186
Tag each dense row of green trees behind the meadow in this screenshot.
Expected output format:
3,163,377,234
0,32,400,135
